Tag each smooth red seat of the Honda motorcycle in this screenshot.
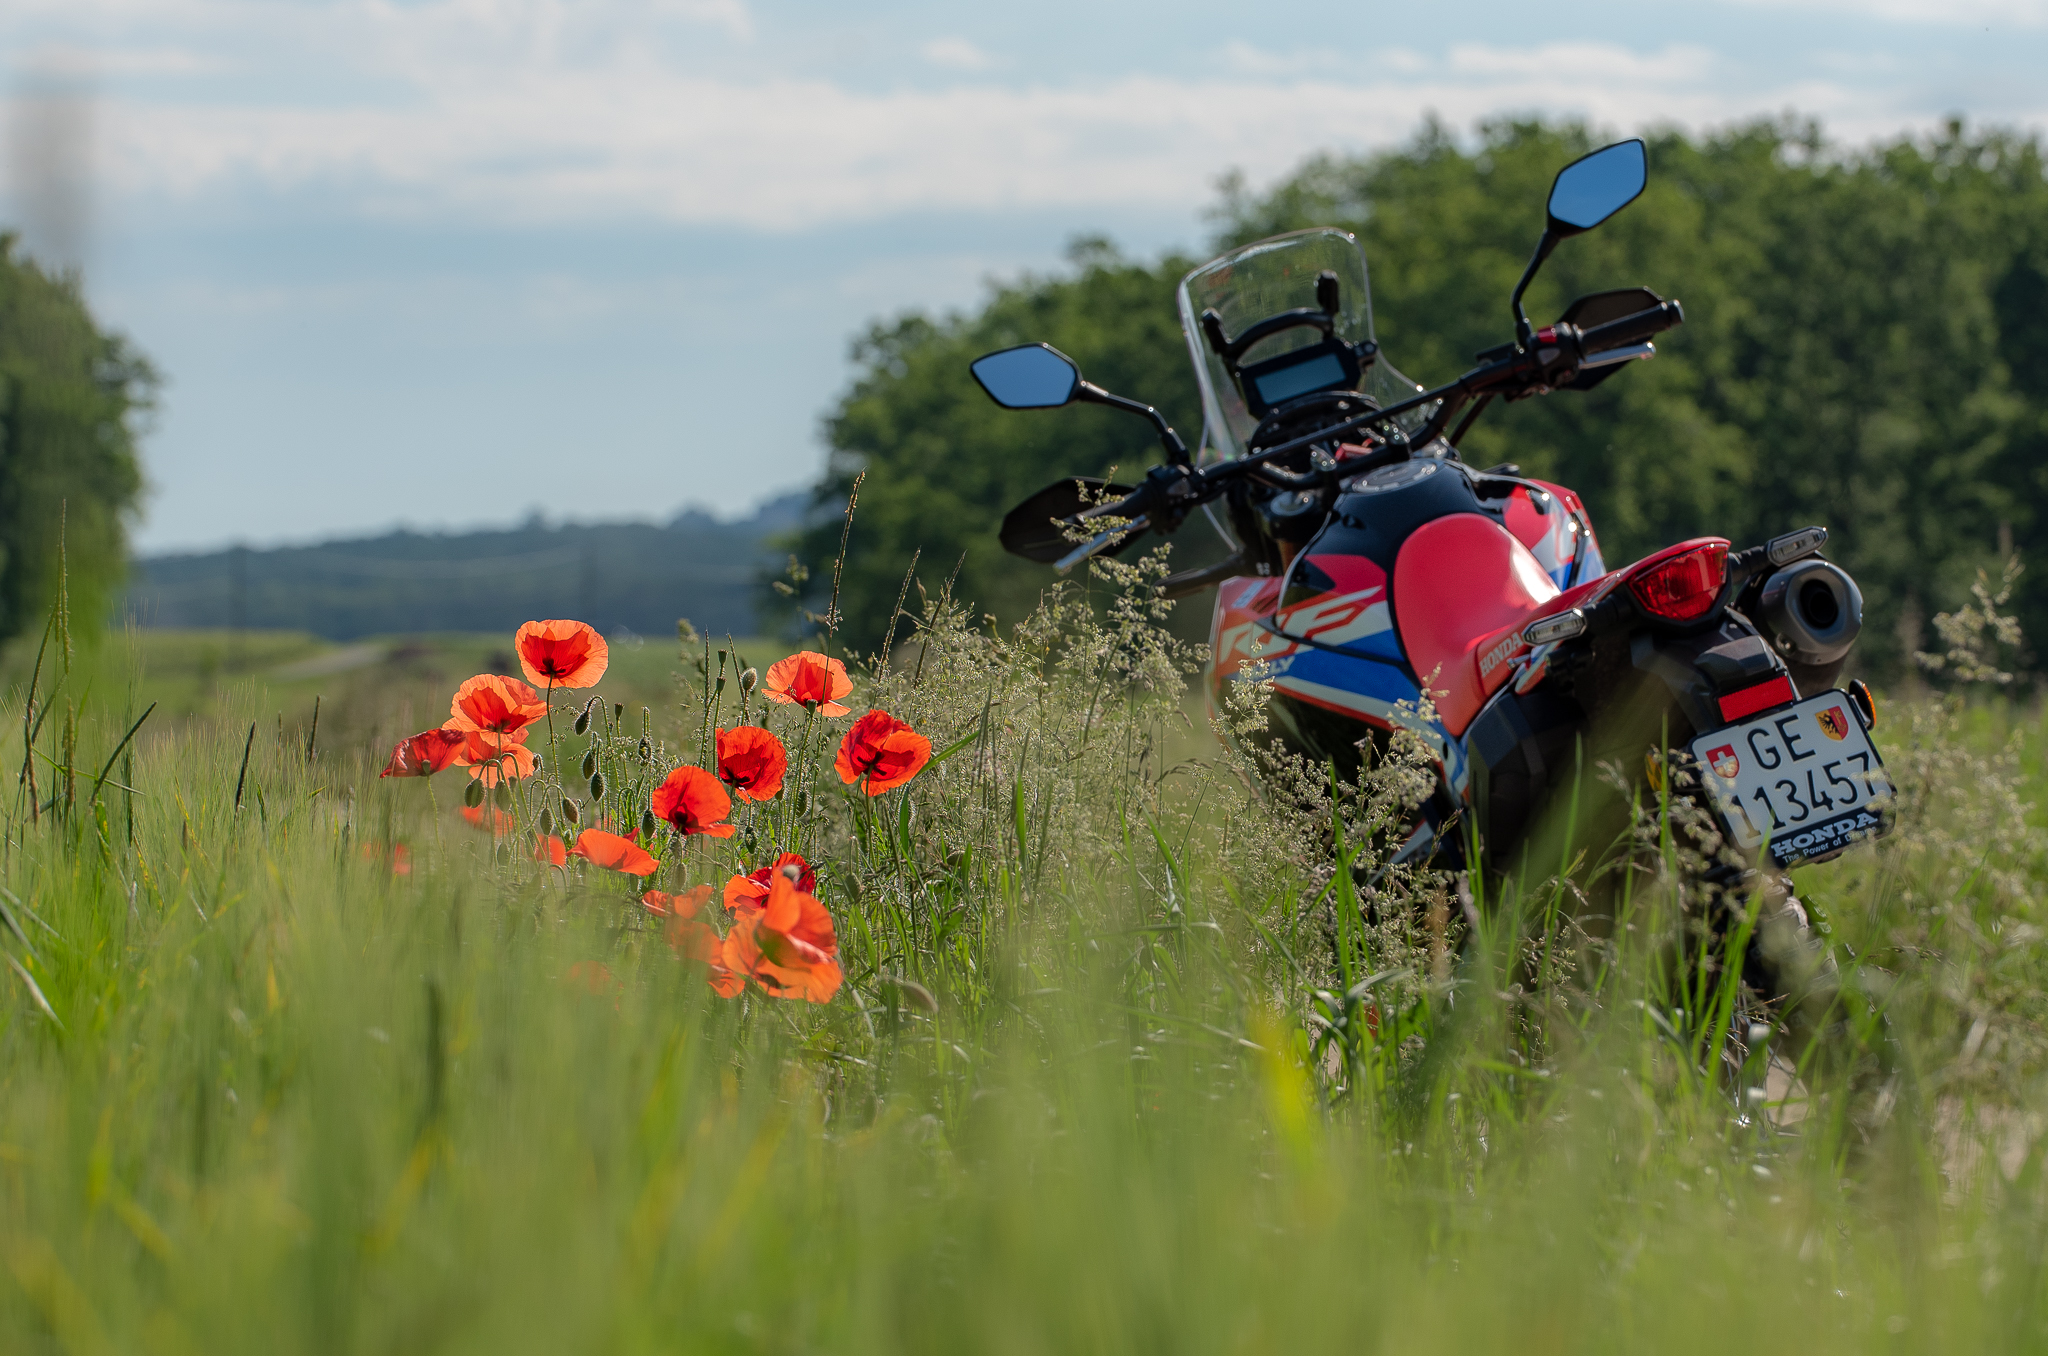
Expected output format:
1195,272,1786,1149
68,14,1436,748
1393,514,1559,737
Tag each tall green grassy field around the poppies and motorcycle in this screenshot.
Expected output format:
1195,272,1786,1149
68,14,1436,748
0,594,2048,1354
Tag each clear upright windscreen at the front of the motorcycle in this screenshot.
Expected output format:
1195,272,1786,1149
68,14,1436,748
1180,225,1421,461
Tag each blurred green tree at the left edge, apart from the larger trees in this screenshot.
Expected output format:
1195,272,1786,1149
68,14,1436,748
0,234,156,639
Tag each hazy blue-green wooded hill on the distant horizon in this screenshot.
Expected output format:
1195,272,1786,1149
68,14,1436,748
123,492,809,641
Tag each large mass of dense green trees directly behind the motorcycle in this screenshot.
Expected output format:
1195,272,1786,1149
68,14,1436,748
797,123,2048,670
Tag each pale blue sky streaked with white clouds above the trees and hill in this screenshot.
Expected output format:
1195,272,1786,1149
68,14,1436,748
0,0,2048,551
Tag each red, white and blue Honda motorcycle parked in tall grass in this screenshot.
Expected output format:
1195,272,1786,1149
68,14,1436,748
971,141,1894,989
